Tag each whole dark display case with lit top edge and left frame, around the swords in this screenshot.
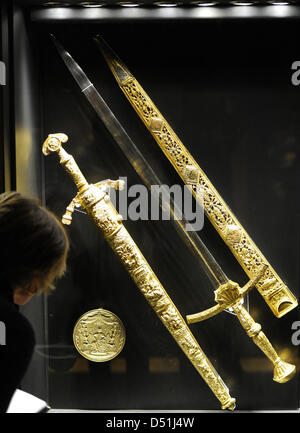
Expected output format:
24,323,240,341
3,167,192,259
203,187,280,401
0,0,300,411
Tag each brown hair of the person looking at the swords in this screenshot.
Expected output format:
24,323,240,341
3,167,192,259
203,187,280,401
0,192,69,291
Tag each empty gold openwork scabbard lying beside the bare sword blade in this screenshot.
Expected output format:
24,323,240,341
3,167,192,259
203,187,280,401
95,36,298,318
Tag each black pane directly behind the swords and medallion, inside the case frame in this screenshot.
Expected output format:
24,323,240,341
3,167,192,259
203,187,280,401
36,21,300,410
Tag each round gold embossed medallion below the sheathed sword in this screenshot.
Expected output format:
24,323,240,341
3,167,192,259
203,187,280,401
73,308,126,362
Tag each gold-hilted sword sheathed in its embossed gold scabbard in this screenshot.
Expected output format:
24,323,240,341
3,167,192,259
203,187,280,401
43,133,235,410
